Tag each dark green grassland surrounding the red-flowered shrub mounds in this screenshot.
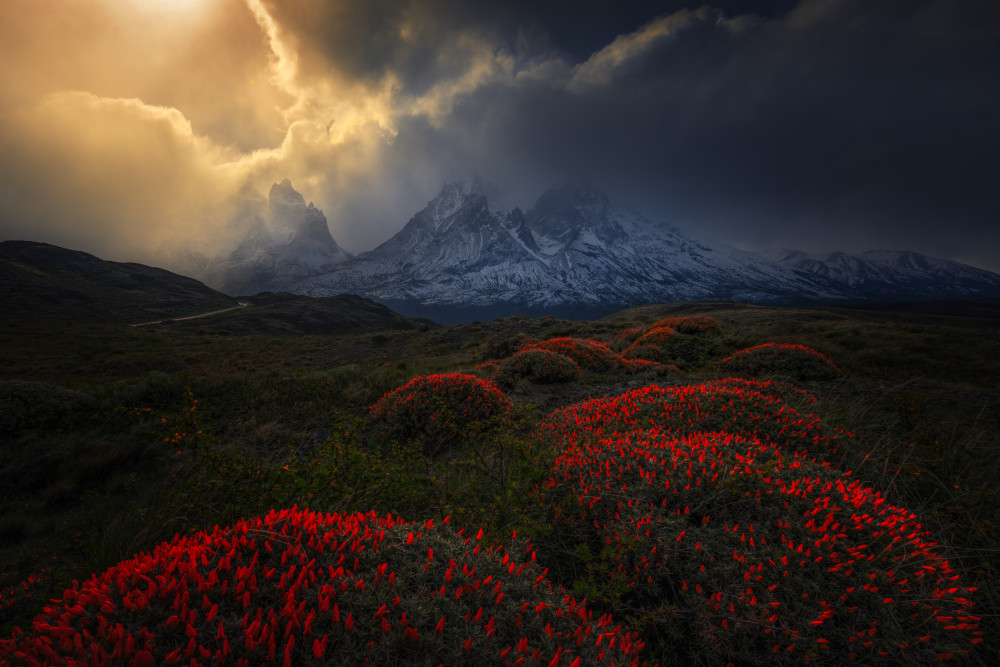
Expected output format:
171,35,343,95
0,303,1000,665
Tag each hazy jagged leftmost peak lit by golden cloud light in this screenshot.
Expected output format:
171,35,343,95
199,178,352,294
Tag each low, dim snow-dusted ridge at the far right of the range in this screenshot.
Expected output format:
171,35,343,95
760,248,1000,300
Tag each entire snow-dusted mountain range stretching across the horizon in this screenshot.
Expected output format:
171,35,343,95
198,180,1000,322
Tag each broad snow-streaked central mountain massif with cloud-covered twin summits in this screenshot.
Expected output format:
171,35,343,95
292,183,841,320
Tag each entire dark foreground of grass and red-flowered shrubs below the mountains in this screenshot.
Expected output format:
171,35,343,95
0,304,1000,665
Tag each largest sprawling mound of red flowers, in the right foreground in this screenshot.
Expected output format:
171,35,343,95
535,379,982,664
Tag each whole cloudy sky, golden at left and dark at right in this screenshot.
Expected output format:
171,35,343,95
0,0,1000,272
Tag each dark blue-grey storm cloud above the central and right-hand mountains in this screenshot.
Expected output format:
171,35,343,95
322,0,1000,269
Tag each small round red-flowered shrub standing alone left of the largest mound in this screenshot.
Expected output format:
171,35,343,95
369,373,511,456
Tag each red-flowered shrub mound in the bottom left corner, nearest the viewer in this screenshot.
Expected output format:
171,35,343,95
0,508,643,667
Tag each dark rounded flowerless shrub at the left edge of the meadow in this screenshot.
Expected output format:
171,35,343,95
0,380,95,436
